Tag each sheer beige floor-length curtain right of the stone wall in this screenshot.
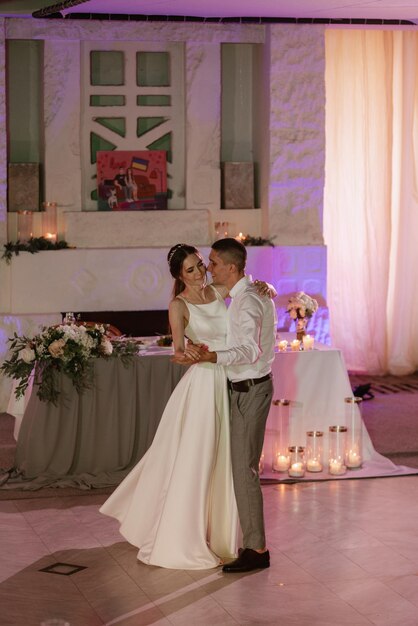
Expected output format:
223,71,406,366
324,30,418,375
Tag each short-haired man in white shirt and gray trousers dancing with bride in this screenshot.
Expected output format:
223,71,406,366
193,238,276,573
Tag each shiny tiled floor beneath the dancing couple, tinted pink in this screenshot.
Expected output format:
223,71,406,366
0,476,418,626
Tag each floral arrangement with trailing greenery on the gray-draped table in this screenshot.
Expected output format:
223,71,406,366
0,323,137,405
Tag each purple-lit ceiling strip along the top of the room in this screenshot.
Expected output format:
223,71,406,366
0,0,418,23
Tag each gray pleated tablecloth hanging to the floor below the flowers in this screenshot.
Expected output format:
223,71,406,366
6,354,186,489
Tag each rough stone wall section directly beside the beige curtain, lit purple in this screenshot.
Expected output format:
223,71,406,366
268,25,325,245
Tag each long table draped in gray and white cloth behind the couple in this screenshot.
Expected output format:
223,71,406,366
5,336,408,489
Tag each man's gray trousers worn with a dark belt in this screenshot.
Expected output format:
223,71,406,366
231,380,273,550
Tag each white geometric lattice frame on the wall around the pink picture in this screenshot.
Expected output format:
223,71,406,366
81,41,185,211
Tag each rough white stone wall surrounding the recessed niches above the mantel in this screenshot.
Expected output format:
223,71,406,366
0,19,325,247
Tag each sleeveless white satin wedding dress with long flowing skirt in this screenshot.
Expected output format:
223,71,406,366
100,290,238,569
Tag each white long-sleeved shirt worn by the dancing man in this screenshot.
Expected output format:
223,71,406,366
216,276,277,382
